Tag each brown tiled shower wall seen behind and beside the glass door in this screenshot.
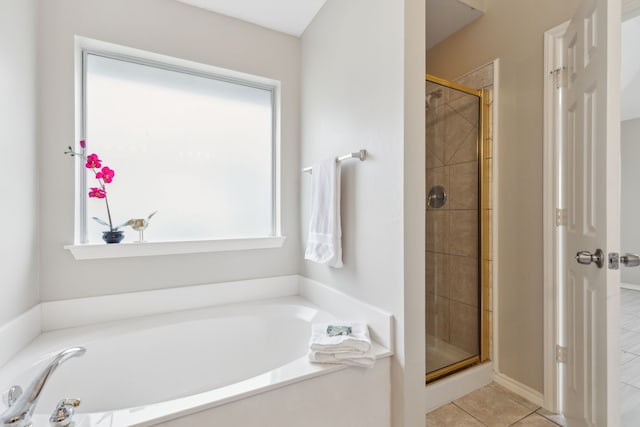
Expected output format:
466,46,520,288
426,64,493,357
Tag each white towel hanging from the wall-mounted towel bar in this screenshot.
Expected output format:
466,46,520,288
304,158,342,268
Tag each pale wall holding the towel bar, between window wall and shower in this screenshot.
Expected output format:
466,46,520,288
300,0,424,427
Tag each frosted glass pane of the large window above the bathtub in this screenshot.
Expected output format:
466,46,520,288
83,54,274,242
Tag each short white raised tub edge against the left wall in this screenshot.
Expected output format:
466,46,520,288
0,304,42,366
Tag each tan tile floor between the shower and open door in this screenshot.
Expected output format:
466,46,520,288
427,383,564,427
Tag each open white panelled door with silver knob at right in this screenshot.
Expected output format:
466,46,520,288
562,0,620,427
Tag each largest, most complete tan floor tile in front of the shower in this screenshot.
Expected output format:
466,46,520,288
454,384,534,427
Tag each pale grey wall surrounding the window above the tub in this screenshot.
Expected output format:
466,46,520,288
38,0,300,301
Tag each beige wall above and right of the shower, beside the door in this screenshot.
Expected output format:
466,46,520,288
427,0,579,393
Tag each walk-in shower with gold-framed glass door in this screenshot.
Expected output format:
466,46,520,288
425,75,488,382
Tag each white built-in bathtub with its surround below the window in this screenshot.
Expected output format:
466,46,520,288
0,276,392,427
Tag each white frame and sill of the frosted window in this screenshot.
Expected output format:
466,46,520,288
65,36,286,259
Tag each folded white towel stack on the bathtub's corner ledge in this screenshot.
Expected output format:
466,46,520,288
309,322,372,355
